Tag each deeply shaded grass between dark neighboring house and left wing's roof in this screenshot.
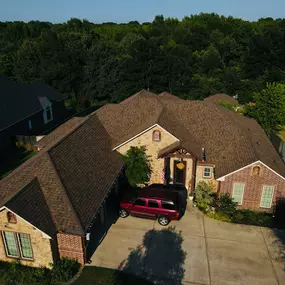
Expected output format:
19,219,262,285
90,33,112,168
0,148,36,179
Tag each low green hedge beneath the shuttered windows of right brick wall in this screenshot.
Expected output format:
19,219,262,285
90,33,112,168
233,210,273,227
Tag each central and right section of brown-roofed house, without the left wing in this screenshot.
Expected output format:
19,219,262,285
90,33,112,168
96,91,285,211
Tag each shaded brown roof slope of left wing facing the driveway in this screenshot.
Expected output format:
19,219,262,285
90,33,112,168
49,116,123,230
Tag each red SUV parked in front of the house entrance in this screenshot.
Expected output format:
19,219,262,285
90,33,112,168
120,187,181,226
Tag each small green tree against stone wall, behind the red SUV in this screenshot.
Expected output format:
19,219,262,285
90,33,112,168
124,146,151,186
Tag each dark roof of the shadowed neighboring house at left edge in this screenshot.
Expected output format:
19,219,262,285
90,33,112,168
0,77,64,130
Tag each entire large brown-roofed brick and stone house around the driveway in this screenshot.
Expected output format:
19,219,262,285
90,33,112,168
0,90,285,266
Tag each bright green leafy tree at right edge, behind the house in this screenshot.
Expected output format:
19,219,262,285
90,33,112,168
243,83,285,134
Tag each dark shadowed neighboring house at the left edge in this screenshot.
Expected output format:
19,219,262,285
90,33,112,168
0,77,68,149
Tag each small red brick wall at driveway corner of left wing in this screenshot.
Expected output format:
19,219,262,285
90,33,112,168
57,233,85,264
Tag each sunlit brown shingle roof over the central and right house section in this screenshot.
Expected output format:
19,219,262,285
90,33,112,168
96,90,285,177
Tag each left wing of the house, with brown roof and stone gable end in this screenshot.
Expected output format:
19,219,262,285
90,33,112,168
0,113,123,267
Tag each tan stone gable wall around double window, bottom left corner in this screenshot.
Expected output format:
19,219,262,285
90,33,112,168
0,210,54,267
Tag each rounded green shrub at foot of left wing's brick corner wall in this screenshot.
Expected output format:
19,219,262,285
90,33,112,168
51,257,80,283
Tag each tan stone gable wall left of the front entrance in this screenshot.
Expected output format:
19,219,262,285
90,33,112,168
117,127,178,183
